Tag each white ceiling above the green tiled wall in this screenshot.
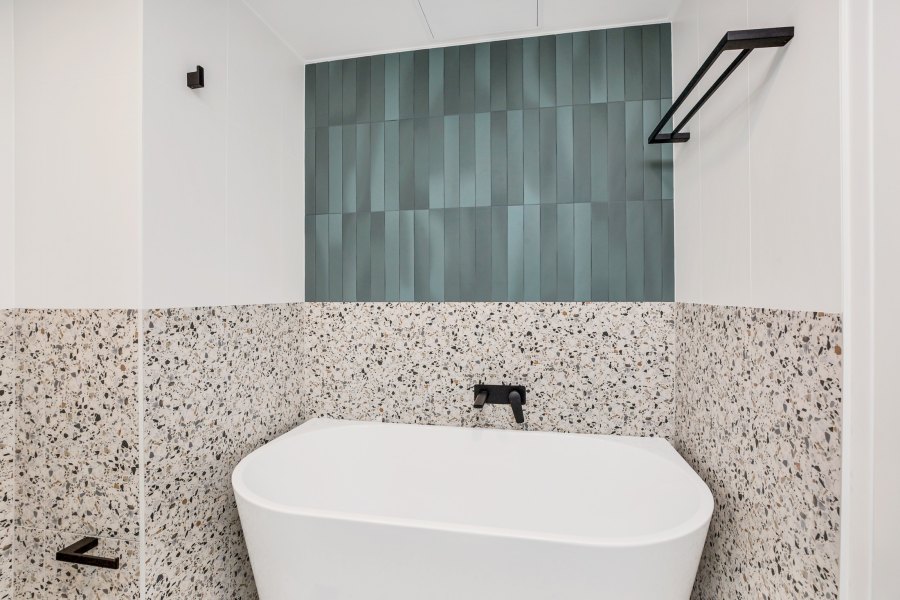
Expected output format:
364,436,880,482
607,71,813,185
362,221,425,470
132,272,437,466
244,0,680,62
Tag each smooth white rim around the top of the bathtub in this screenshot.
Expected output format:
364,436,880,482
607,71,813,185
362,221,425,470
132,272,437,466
231,417,715,548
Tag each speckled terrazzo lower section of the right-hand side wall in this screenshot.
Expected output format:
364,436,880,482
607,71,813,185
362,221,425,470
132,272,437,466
674,304,842,600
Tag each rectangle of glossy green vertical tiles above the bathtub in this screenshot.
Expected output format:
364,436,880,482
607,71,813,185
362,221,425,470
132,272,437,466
305,24,674,301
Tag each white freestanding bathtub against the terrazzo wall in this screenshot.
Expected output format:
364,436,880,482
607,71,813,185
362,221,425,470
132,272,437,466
232,419,713,600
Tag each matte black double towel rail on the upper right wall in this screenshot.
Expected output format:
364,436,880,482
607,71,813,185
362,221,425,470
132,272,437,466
647,27,794,144
